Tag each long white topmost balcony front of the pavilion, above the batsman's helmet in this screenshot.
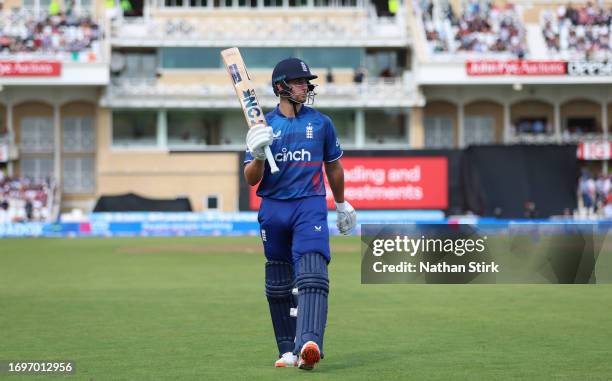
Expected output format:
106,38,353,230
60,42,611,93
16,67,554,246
112,10,408,47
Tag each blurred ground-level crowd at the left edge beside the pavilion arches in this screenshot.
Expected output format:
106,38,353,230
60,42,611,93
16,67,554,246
0,171,52,223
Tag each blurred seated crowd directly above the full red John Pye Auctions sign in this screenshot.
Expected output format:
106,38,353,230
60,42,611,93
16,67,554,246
421,0,527,57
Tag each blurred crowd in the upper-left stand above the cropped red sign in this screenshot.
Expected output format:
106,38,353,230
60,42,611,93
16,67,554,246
0,11,102,61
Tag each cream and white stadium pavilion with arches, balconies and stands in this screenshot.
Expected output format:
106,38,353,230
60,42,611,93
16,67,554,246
0,0,612,211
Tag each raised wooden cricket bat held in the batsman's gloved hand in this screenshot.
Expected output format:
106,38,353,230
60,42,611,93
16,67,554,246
221,48,278,173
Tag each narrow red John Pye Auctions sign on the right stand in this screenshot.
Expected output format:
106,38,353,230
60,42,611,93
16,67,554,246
465,60,567,76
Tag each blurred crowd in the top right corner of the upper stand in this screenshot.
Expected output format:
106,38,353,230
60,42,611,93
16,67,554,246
542,2,612,59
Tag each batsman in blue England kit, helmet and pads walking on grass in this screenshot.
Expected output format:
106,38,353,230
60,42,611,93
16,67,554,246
244,58,356,370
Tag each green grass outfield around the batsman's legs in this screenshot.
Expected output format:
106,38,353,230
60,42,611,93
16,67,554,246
0,238,612,381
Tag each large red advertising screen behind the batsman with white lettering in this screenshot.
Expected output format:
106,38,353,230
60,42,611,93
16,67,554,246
249,157,448,210
